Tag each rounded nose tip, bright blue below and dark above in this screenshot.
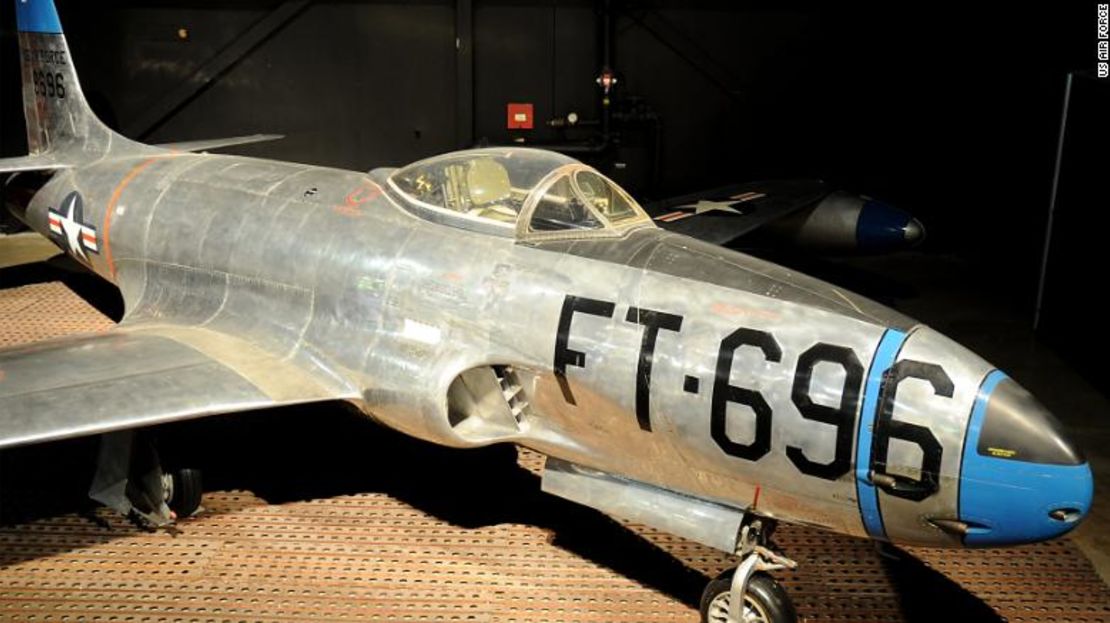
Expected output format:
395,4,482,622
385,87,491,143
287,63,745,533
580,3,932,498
959,371,1094,545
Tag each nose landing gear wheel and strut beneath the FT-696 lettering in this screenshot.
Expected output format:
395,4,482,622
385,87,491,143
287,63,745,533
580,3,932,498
702,519,798,623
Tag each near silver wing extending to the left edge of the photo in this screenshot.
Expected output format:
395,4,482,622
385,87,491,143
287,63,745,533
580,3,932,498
0,324,359,448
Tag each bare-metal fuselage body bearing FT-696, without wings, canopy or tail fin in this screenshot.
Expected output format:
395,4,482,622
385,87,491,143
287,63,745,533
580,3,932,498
24,152,1089,545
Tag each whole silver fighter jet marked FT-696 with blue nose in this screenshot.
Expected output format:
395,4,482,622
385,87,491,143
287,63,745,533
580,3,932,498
0,0,1092,623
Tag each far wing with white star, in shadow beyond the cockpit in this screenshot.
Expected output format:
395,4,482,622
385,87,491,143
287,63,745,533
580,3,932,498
644,180,830,244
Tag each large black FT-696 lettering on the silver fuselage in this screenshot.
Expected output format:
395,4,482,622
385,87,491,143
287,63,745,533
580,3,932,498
554,294,955,501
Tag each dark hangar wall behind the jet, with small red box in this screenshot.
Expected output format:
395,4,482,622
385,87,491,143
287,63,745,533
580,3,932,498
0,0,1110,364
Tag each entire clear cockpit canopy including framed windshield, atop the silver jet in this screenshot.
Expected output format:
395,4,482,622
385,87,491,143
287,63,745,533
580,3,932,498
390,148,650,239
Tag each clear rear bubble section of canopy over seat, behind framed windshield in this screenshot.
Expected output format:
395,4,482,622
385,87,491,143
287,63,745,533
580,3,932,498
391,149,575,224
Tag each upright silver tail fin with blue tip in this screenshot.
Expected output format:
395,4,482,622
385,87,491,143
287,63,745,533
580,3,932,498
9,0,150,171
